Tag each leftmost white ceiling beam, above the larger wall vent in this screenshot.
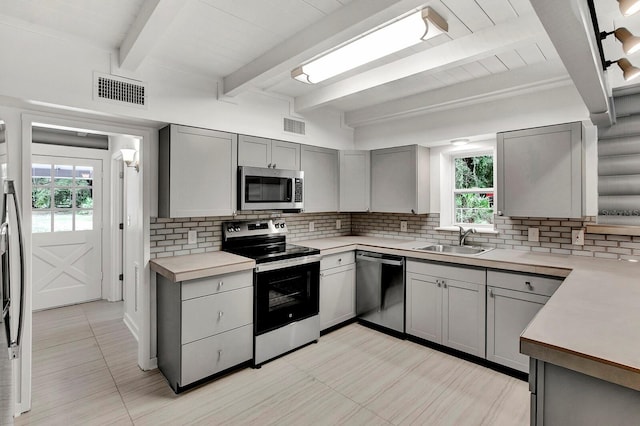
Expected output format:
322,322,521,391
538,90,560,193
119,0,187,71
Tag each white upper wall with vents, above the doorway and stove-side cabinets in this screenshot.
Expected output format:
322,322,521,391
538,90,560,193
0,23,353,149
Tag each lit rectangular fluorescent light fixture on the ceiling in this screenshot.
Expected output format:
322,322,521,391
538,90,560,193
291,7,449,83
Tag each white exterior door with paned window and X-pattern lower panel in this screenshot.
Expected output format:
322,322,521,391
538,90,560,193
31,156,102,310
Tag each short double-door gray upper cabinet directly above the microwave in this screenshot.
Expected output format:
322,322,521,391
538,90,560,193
238,135,300,170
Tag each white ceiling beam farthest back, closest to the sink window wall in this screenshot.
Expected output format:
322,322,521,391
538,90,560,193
345,59,571,127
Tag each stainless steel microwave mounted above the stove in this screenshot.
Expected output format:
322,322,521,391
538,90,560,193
238,166,304,212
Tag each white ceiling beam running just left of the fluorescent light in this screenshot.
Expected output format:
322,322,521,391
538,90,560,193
223,0,432,96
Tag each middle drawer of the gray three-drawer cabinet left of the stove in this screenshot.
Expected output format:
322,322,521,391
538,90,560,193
181,287,253,344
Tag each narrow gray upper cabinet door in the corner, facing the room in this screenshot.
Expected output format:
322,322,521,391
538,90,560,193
340,151,371,212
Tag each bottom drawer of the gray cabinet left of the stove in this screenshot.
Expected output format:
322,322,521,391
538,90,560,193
180,325,253,386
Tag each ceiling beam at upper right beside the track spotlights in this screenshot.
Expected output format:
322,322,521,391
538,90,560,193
531,0,618,126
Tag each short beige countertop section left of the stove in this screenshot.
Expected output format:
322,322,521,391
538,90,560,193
149,251,256,283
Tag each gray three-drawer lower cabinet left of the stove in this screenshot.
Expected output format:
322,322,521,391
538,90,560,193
157,271,253,392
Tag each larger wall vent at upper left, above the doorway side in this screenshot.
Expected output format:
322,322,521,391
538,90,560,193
93,73,147,108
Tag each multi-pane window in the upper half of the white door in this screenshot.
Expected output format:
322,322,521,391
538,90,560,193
31,164,93,233
